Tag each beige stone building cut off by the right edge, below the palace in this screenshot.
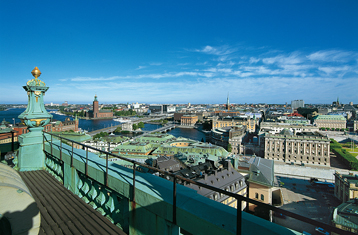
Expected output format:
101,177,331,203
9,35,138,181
334,172,358,202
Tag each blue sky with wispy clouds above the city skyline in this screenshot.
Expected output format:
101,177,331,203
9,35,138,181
0,0,358,103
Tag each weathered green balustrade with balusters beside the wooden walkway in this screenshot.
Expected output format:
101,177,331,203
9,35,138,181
2,133,356,234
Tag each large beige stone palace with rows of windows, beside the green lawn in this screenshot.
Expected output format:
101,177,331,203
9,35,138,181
263,129,330,166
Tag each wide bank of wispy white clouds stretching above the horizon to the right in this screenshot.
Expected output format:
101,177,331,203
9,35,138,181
49,46,358,103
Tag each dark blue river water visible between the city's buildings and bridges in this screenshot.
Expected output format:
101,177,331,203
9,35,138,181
0,109,206,141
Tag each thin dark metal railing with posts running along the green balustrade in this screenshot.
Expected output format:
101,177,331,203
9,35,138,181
43,132,355,235
